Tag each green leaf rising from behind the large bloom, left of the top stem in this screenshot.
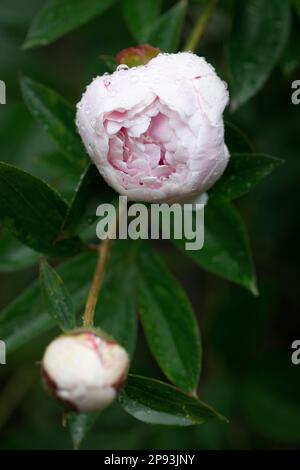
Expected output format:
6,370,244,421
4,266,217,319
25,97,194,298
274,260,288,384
140,0,187,52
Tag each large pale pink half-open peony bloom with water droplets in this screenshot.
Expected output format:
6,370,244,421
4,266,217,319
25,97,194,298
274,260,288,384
77,52,229,202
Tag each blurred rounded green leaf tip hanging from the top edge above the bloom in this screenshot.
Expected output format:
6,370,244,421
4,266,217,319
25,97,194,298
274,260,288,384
123,0,162,42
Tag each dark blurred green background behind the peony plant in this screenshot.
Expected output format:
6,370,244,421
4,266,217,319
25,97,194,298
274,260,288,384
0,0,300,449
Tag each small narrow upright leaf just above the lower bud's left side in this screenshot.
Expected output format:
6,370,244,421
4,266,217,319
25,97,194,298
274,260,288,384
40,259,76,331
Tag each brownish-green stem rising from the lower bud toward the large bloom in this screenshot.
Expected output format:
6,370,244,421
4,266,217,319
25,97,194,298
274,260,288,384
83,237,112,326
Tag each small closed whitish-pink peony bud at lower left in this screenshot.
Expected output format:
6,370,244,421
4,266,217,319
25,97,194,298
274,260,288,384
42,331,129,413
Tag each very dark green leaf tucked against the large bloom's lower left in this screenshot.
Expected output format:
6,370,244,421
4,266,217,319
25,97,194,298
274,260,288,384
63,163,115,233
